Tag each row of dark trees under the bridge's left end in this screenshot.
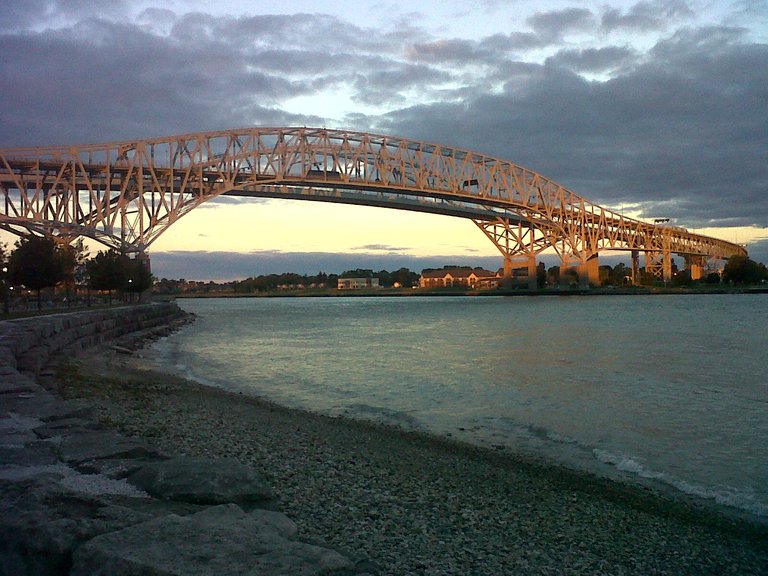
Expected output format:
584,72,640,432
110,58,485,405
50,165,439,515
0,236,153,309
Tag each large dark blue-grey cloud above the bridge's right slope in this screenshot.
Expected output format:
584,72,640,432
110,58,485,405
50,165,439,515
378,28,768,227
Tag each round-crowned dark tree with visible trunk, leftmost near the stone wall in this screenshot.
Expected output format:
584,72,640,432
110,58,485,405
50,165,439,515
8,236,66,310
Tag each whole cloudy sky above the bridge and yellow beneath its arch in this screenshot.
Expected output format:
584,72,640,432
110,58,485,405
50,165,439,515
0,0,768,279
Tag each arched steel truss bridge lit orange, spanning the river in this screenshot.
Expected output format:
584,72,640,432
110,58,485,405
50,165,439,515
0,128,746,281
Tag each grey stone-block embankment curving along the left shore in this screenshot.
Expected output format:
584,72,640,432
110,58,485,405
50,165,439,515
0,304,372,576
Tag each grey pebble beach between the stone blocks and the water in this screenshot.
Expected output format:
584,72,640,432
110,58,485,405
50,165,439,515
59,348,768,575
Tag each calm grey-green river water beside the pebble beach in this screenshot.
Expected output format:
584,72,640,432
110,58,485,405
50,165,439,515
146,295,768,519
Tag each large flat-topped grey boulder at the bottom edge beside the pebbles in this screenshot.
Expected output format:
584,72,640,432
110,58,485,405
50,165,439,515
70,504,354,576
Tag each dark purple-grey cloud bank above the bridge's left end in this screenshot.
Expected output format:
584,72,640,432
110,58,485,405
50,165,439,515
0,20,326,146
